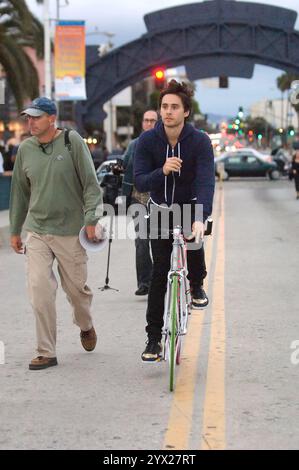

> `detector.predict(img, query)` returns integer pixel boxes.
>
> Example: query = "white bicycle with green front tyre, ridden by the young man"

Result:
[162,219,213,392]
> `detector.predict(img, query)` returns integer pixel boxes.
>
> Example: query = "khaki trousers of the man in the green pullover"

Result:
[26,232,92,357]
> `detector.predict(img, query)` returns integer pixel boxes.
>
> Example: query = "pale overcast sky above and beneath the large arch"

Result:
[26,0,299,115]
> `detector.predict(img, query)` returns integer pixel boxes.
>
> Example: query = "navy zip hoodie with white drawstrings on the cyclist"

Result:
[134,121,215,220]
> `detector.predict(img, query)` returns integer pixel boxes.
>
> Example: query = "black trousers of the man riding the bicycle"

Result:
[146,237,207,340]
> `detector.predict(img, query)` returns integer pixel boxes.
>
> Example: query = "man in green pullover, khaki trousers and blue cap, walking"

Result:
[10,97,102,370]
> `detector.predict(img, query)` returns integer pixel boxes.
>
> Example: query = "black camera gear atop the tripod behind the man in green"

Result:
[96,155,123,212]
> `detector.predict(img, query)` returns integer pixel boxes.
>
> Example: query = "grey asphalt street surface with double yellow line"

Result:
[0,178,299,450]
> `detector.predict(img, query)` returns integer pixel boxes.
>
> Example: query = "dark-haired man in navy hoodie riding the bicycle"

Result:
[134,80,215,362]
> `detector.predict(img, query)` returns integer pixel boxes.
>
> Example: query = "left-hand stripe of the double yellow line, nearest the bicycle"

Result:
[163,188,219,450]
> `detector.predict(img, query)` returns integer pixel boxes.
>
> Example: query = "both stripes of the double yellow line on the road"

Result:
[163,188,225,450]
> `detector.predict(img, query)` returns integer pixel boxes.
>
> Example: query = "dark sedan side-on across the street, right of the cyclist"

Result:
[215,148,280,180]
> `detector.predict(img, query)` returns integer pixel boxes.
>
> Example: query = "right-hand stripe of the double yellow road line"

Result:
[201,187,226,450]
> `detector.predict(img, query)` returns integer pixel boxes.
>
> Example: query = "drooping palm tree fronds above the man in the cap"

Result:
[0,0,43,110]
